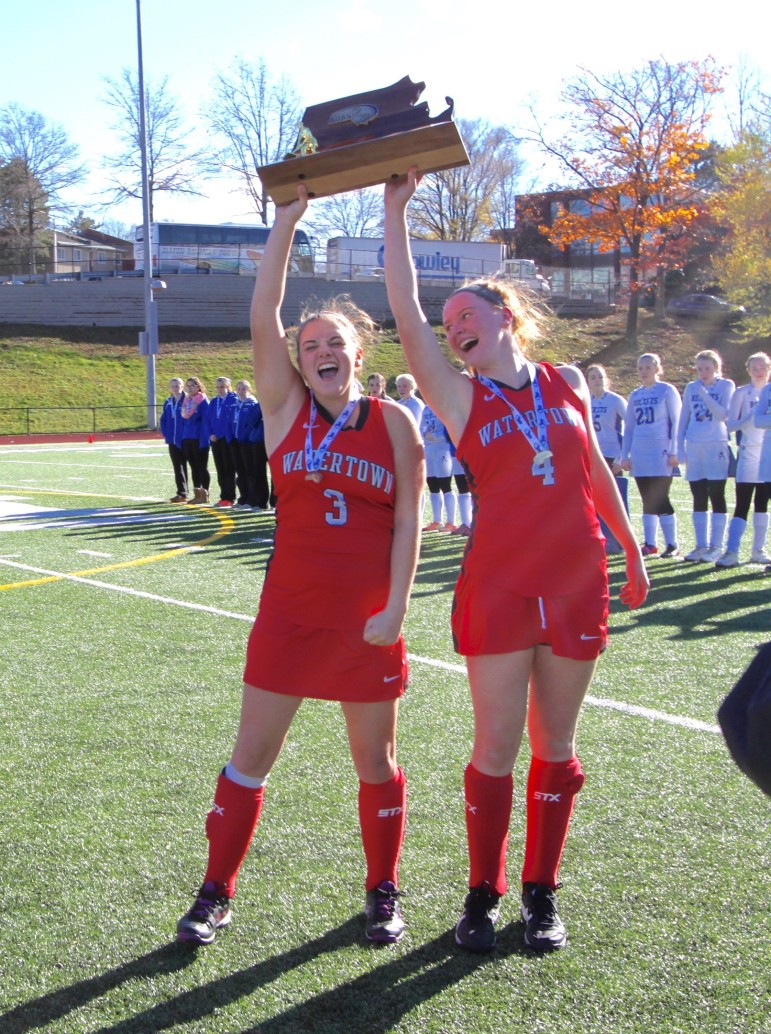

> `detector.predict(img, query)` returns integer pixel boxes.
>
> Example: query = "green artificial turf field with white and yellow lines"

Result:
[0,442,771,1034]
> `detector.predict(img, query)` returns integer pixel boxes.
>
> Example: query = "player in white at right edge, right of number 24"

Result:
[715,352,771,568]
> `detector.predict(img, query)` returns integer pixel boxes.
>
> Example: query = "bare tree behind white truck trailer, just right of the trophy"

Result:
[409,119,521,241]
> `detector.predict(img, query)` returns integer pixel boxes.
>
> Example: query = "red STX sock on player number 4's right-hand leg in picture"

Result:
[522,757,584,887]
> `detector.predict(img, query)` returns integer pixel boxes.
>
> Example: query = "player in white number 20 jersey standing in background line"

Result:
[619,352,681,557]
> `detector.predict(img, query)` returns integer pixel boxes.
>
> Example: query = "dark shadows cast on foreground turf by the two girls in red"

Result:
[0,915,533,1034]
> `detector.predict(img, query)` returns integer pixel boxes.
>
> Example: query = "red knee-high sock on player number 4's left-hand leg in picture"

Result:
[465,764,514,894]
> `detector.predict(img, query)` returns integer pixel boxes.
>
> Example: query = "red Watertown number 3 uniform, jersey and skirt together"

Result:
[244,394,407,701]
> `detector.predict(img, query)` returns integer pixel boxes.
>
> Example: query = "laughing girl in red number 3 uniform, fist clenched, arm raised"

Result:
[177,186,425,944]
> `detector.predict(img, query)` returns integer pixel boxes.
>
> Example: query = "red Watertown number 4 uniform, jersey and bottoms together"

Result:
[453,363,608,659]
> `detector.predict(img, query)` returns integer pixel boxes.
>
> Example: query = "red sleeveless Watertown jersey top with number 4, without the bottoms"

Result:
[457,363,607,597]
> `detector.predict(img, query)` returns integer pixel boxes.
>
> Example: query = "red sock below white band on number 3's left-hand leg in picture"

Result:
[206,772,265,898]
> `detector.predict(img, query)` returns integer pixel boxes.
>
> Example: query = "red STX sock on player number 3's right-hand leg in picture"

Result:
[359,768,407,890]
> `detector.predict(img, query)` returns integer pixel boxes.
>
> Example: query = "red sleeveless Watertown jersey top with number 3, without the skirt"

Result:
[260,394,396,629]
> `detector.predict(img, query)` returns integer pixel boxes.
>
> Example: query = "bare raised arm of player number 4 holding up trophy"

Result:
[384,169,472,442]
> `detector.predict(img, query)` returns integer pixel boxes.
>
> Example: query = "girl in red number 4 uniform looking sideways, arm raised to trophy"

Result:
[386,170,648,951]
